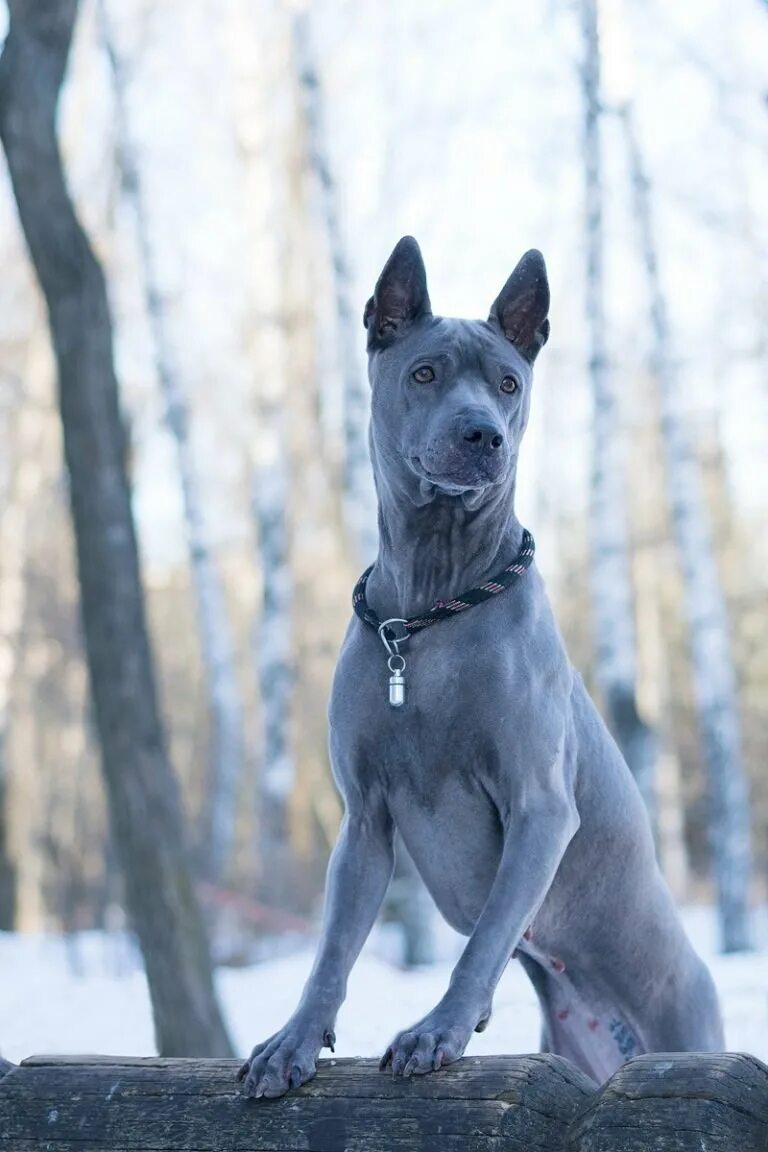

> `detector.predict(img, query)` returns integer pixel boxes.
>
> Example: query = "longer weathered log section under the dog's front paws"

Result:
[0,1055,595,1152]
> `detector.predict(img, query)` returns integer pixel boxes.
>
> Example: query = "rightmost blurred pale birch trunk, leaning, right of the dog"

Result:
[621,105,752,952]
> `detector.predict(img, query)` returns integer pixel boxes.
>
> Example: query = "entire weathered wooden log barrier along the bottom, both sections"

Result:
[0,1053,768,1152]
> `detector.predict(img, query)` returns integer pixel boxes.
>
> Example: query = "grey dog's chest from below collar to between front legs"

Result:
[332,604,571,932]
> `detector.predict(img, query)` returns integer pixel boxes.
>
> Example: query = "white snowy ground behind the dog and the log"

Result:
[0,909,768,1061]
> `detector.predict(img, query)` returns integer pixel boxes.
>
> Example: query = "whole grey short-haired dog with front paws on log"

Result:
[239,237,723,1097]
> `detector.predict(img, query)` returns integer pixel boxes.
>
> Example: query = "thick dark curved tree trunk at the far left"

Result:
[0,0,230,1056]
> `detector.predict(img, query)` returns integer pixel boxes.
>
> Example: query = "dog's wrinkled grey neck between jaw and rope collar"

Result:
[367,478,523,620]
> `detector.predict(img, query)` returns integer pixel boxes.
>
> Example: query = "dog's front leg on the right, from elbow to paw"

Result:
[381,764,579,1076]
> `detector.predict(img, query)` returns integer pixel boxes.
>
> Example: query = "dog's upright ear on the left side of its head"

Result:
[363,236,432,349]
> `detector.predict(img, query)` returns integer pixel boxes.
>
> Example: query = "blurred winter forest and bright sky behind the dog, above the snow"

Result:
[0,0,768,1054]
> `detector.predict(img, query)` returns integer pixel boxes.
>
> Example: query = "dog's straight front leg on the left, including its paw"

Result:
[238,801,394,1097]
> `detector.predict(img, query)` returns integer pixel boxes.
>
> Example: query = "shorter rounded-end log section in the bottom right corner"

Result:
[567,1052,768,1152]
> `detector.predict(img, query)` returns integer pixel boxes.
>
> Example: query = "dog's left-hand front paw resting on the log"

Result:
[237,1017,336,1097]
